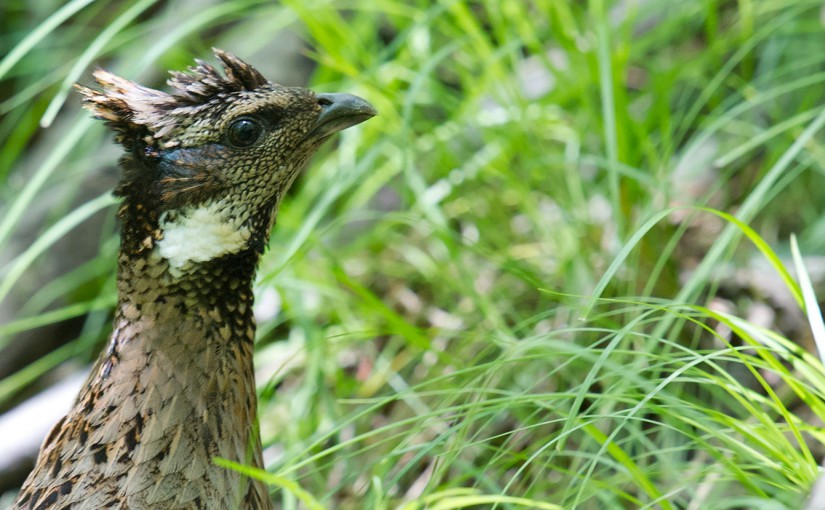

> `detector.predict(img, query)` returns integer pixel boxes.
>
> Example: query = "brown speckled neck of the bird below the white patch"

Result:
[20,237,272,510]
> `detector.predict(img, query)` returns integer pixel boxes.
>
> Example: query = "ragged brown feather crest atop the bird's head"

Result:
[75,48,269,146]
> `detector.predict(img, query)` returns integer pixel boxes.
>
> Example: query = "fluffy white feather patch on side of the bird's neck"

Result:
[155,201,251,277]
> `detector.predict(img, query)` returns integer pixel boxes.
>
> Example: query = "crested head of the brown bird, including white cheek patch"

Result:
[76,49,376,275]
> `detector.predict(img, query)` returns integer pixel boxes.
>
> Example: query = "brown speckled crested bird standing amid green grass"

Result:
[12,48,376,510]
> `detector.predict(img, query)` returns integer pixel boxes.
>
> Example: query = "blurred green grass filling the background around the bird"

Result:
[0,0,825,510]
